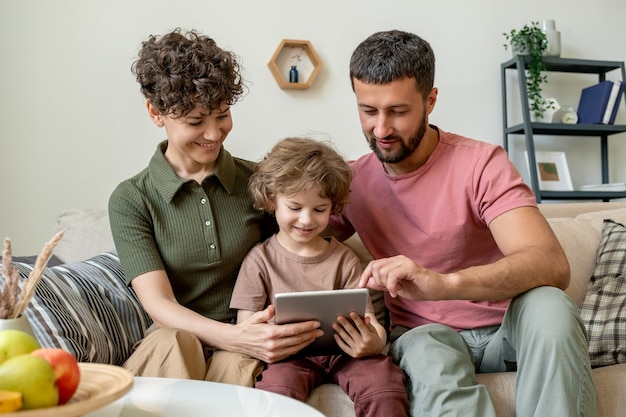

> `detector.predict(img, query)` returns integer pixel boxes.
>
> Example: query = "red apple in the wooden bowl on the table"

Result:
[30,348,80,404]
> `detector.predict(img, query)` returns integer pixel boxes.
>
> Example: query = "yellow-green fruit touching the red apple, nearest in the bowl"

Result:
[0,355,59,410]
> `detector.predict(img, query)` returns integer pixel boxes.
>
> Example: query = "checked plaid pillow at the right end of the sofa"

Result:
[581,219,626,367]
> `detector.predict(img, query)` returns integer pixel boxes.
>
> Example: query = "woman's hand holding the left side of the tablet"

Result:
[230,306,324,363]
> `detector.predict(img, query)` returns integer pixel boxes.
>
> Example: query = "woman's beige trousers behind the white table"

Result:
[123,328,263,387]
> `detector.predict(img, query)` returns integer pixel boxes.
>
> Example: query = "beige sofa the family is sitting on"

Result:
[33,202,626,417]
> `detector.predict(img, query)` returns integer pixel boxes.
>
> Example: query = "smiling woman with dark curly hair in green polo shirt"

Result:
[109,29,321,386]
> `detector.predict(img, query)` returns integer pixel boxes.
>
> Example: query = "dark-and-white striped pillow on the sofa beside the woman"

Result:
[6,252,151,365]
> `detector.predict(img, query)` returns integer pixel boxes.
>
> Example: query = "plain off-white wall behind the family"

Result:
[0,0,626,255]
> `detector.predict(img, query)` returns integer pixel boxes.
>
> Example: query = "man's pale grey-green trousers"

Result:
[390,287,596,417]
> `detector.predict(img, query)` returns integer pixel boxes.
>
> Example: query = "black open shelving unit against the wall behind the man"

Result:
[501,55,626,203]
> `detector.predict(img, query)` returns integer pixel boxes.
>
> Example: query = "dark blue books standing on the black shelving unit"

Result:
[577,80,624,125]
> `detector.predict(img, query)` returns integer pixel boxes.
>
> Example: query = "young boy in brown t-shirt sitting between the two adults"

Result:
[230,138,408,417]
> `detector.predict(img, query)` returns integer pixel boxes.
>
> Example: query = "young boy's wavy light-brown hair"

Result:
[249,137,352,214]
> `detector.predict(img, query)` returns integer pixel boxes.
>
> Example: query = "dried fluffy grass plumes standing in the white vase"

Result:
[0,230,65,319]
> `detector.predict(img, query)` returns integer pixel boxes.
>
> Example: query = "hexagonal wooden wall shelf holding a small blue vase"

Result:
[267,39,322,90]
